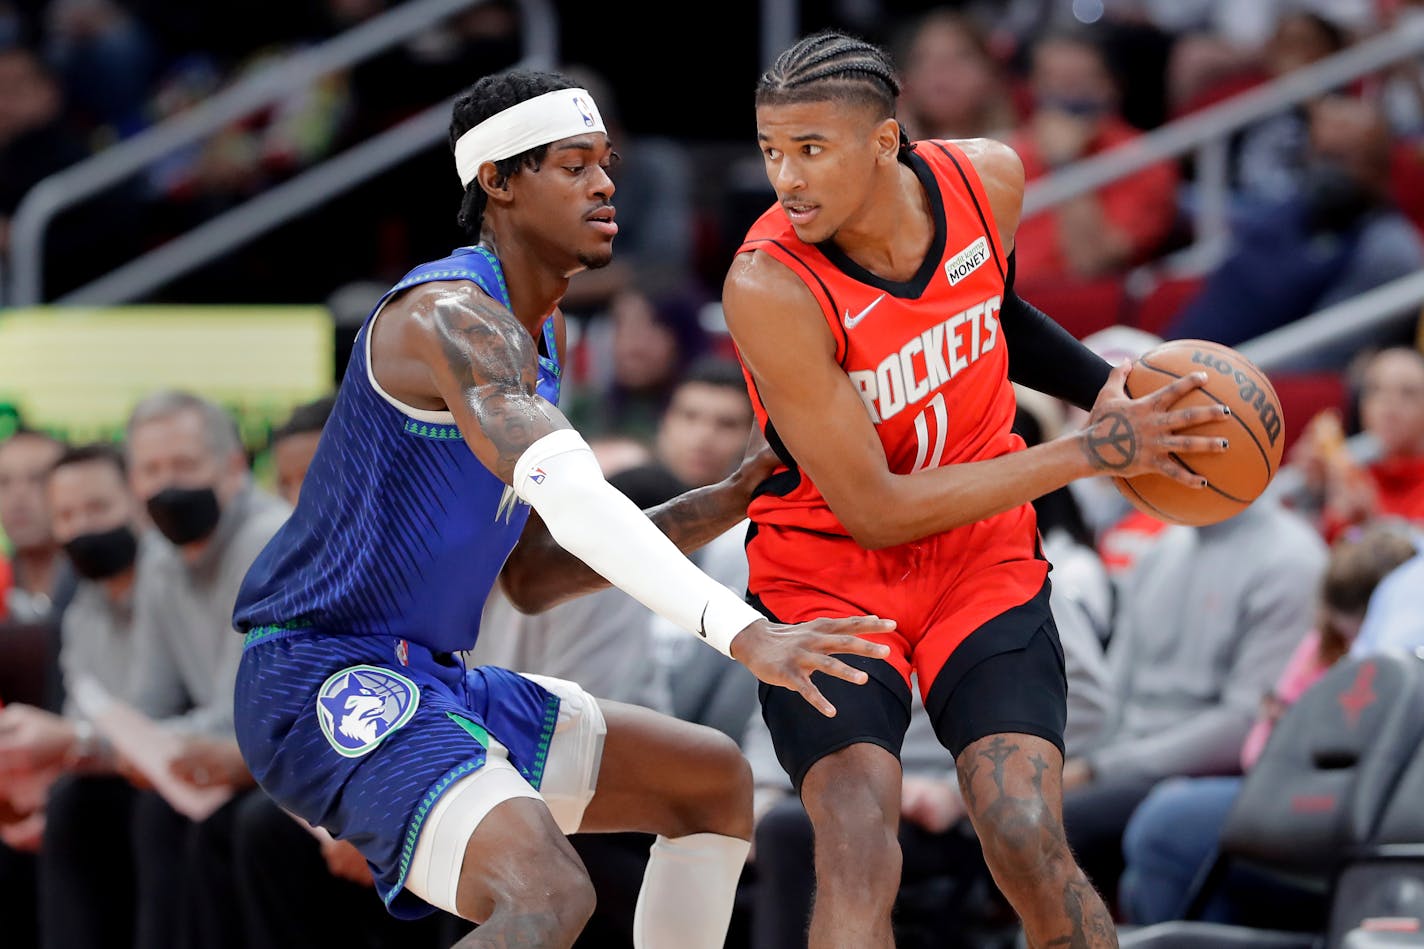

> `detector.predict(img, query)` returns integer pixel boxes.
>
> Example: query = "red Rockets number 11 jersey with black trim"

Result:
[738,140,1034,536]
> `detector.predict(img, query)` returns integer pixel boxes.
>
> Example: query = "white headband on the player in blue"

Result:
[454,88,607,187]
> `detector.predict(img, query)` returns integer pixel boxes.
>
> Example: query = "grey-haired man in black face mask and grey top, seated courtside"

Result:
[127,390,290,949]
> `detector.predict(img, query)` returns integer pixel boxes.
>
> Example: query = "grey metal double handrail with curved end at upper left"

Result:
[9,0,558,306]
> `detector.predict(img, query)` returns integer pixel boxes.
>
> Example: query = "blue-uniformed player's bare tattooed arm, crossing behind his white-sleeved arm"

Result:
[500,449,778,613]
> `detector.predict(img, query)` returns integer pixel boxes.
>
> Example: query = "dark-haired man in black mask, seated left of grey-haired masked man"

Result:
[0,445,153,949]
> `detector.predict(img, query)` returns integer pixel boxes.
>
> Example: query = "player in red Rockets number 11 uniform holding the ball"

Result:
[722,33,1225,949]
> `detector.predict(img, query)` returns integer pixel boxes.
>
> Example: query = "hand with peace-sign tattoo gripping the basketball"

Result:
[1078,362,1230,487]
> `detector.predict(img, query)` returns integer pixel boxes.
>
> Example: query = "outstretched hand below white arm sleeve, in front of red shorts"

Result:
[732,616,894,718]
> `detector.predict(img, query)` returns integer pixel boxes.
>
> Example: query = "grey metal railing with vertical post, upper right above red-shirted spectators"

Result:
[1024,20,1424,262]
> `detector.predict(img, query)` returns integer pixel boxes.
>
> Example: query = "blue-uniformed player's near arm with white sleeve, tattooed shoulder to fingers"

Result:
[395,285,894,715]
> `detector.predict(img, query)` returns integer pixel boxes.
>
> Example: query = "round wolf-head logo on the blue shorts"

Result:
[316,665,420,758]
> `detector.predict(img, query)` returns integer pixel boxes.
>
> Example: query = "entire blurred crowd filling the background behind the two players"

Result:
[0,0,1424,949]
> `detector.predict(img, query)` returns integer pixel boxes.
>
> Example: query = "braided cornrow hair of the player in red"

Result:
[756,30,914,151]
